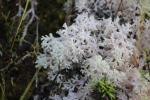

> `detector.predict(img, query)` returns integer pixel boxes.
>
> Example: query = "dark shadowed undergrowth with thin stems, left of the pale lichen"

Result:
[0,0,65,100]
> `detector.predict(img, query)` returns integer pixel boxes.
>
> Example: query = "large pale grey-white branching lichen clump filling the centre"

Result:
[36,0,150,100]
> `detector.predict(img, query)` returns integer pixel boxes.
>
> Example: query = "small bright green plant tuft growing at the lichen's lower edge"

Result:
[96,78,116,100]
